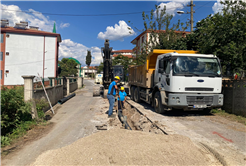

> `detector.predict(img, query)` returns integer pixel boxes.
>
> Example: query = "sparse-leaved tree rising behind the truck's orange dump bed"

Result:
[129,5,189,65]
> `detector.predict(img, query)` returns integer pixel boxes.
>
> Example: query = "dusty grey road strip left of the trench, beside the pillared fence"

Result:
[2,80,106,165]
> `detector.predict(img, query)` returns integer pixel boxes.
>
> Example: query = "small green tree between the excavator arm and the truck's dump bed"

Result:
[112,54,134,81]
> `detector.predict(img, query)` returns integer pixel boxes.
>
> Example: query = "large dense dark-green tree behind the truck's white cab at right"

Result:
[194,0,246,72]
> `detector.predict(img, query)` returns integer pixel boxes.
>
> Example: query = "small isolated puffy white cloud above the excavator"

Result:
[97,20,135,41]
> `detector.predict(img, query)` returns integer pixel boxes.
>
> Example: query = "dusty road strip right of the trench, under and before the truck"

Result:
[128,100,246,165]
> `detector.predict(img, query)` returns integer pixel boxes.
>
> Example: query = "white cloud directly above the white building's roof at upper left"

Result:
[0,4,66,32]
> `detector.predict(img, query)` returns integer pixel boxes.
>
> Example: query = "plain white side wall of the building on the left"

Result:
[4,33,56,85]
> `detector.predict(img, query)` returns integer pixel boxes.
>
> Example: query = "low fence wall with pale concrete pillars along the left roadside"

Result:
[22,76,83,117]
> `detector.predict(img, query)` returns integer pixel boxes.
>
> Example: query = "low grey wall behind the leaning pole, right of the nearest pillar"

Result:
[33,85,64,105]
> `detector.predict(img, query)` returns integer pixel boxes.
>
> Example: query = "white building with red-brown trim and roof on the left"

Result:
[0,20,61,85]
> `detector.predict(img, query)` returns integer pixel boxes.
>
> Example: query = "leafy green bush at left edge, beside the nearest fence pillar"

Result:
[0,87,32,135]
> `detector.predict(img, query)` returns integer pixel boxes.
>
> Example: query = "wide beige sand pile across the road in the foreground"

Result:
[33,129,209,165]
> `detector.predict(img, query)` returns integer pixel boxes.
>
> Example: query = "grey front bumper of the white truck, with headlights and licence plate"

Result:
[168,93,223,109]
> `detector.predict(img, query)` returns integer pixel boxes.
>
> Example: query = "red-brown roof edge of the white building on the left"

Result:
[0,27,62,42]
